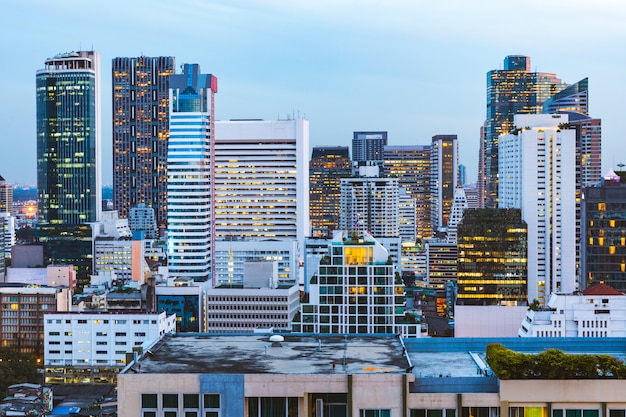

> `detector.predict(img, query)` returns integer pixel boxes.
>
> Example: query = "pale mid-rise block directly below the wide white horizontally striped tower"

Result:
[214,239,299,285]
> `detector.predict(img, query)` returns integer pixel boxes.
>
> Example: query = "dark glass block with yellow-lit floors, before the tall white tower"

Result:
[457,209,528,305]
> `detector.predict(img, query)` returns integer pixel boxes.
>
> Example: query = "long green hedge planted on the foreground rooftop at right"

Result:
[486,343,626,380]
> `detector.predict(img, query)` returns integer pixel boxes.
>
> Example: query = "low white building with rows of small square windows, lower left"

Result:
[43,312,176,383]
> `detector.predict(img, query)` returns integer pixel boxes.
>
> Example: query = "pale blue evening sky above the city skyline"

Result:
[0,0,626,185]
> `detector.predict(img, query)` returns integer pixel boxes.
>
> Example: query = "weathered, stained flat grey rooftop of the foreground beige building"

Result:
[129,334,409,374]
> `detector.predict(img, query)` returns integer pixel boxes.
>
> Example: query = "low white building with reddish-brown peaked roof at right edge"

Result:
[518,283,626,337]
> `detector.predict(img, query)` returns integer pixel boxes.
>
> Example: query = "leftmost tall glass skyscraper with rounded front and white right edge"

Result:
[36,51,102,225]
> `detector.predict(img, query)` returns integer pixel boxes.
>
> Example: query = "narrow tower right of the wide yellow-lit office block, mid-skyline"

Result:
[430,135,459,233]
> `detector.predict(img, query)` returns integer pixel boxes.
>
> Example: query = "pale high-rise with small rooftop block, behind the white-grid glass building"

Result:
[339,166,400,238]
